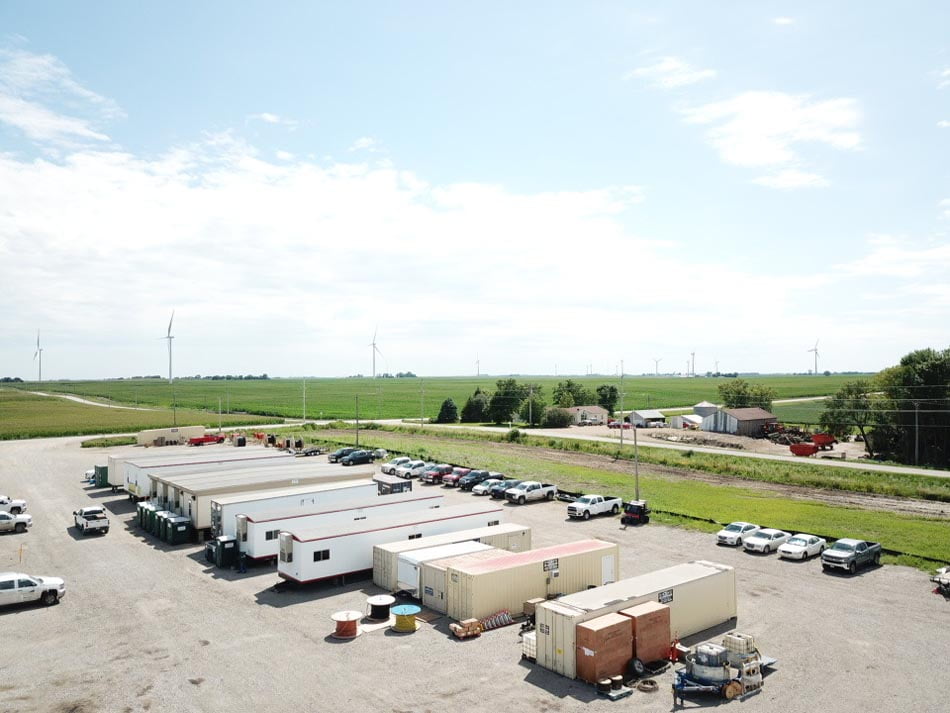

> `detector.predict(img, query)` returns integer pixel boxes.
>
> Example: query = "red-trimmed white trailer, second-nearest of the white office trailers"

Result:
[235,490,442,560]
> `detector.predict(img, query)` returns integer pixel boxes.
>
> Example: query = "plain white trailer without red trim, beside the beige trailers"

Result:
[211,480,379,537]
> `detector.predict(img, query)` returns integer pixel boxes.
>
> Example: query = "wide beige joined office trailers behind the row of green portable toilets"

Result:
[149,459,373,530]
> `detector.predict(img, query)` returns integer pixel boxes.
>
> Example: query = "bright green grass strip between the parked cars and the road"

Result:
[296,422,950,569]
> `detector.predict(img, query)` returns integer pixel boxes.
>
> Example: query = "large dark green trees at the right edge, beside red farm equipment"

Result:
[819,349,950,468]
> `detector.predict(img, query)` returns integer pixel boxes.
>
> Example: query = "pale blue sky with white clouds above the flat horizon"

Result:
[0,0,950,380]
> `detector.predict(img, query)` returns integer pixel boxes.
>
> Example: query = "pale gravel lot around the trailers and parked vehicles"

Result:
[0,438,950,713]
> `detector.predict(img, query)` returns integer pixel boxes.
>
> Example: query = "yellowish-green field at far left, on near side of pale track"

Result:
[0,388,276,440]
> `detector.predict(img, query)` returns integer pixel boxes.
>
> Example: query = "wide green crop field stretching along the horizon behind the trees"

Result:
[23,376,872,418]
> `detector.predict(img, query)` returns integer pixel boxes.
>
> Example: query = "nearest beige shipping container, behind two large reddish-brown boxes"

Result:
[535,560,737,678]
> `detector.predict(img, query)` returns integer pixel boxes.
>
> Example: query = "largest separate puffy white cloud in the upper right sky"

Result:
[682,92,861,188]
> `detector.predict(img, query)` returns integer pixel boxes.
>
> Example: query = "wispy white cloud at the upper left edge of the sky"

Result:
[0,49,124,147]
